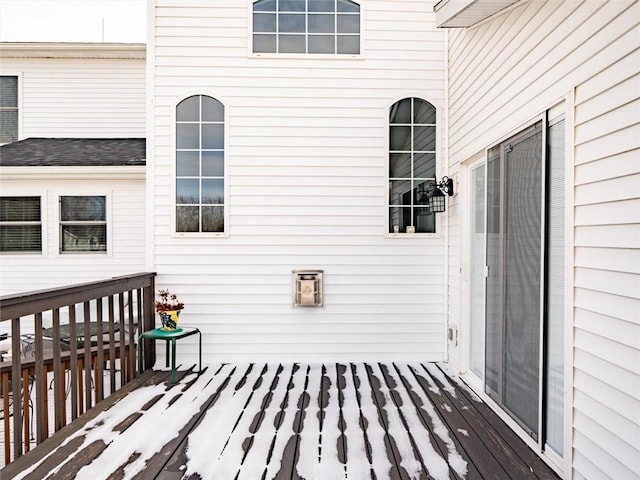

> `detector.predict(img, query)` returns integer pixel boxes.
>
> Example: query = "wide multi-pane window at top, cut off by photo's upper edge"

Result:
[253,0,360,55]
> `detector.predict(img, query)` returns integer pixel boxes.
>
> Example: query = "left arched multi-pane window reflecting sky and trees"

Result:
[176,95,225,232]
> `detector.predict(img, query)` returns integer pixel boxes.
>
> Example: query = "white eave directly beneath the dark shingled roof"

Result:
[0,165,146,182]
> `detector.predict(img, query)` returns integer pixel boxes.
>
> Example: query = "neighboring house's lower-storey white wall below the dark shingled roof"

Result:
[0,167,145,295]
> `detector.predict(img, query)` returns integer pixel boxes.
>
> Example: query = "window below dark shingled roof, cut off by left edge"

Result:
[0,197,42,253]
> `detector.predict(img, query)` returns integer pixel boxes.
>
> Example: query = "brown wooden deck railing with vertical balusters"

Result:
[0,273,155,464]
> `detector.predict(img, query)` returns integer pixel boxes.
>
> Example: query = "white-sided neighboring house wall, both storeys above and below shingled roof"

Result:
[0,43,146,294]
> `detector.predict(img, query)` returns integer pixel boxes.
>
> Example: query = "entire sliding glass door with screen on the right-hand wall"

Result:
[468,113,565,455]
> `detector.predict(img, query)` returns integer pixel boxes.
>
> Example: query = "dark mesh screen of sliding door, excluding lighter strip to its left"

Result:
[503,124,542,438]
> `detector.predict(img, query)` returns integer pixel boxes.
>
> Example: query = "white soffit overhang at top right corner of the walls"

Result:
[434,0,521,28]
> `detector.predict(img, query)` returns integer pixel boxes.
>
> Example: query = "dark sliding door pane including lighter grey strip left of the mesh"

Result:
[485,122,543,438]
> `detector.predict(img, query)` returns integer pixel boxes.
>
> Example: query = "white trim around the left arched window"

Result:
[168,90,229,238]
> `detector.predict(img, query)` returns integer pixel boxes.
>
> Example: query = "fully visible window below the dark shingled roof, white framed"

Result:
[60,196,107,253]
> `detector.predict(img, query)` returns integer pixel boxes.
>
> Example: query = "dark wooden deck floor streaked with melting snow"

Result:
[0,363,558,480]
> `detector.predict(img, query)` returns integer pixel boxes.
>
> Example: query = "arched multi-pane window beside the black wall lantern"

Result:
[389,97,436,233]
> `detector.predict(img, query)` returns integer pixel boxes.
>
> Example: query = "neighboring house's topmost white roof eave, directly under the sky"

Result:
[0,42,147,60]
